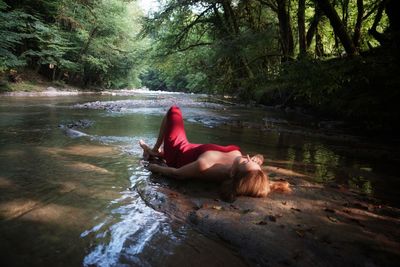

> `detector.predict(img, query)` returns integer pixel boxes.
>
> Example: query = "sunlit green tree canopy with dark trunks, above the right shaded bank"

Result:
[144,0,398,97]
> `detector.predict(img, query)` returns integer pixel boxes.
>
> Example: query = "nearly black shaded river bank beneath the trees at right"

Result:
[256,47,400,136]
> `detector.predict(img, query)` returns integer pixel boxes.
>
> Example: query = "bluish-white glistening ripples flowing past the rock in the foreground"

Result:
[81,171,173,266]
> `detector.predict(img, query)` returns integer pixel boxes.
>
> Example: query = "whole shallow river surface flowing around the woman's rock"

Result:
[0,93,399,266]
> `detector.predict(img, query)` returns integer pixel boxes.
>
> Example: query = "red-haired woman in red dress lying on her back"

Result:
[139,106,290,200]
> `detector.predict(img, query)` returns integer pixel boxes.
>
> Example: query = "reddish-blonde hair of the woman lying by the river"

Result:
[221,170,291,201]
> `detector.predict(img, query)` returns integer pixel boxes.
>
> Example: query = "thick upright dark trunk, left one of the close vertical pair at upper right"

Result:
[277,0,294,61]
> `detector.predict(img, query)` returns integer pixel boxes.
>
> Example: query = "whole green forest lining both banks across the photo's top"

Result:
[0,0,400,133]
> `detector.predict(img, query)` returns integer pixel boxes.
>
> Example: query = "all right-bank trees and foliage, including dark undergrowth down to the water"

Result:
[142,0,400,131]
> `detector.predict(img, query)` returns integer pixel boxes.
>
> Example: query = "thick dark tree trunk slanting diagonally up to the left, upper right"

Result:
[316,0,357,56]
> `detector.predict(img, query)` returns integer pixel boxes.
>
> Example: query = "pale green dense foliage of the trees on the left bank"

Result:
[0,0,144,88]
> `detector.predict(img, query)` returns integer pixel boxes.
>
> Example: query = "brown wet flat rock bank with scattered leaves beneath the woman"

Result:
[135,167,400,266]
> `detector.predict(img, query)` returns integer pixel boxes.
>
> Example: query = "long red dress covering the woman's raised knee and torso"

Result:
[164,106,240,168]
